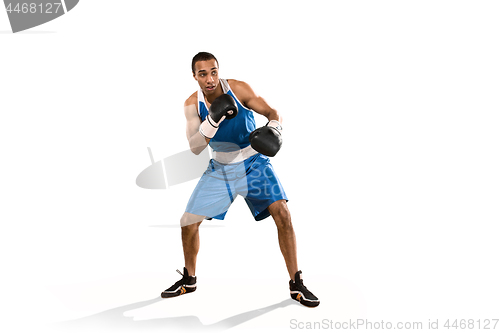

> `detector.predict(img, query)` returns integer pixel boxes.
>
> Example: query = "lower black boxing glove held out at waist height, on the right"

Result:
[249,120,282,157]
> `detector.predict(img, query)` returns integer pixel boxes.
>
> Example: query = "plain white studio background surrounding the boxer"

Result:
[0,0,500,332]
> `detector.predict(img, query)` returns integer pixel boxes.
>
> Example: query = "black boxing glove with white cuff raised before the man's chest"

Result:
[200,94,238,139]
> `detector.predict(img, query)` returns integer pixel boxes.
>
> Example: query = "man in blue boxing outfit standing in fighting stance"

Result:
[161,52,319,307]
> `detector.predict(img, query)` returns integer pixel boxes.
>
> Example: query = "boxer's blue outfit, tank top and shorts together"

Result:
[186,79,288,221]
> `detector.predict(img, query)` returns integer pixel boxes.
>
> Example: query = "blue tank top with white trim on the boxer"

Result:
[198,79,255,152]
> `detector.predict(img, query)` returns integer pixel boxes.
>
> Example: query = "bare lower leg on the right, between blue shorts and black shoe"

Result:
[268,200,299,280]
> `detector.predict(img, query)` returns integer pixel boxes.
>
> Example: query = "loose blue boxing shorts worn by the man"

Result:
[186,154,288,221]
